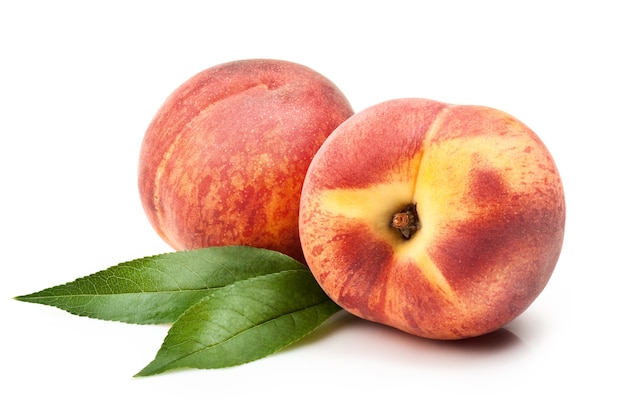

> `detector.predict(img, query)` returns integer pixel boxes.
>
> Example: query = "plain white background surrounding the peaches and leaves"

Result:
[0,0,626,417]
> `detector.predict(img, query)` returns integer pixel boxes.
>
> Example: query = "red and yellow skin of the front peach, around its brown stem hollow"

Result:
[300,99,565,339]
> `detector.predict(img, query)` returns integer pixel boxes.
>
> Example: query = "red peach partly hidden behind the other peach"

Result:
[139,59,354,261]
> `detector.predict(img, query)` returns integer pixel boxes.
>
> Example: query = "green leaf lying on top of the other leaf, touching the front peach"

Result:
[137,271,341,376]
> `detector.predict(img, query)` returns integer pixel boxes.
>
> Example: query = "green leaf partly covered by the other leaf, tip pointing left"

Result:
[16,246,308,324]
